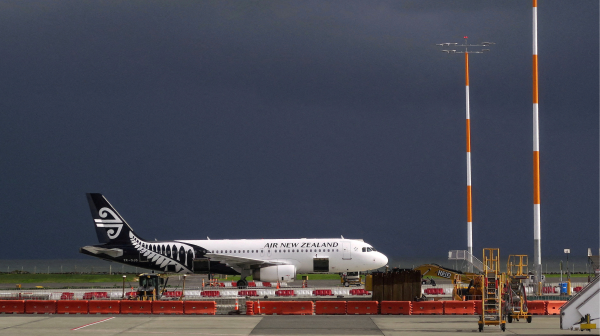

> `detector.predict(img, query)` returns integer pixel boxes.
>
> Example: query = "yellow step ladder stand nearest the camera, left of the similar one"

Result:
[478,248,506,332]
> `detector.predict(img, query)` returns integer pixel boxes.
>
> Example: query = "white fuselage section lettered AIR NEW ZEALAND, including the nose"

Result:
[178,238,388,273]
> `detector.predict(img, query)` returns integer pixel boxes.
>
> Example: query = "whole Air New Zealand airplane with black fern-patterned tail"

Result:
[79,193,388,288]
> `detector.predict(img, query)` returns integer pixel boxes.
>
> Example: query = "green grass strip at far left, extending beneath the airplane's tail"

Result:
[0,274,136,284]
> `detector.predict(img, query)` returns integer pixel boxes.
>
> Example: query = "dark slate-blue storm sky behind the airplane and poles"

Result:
[0,0,600,259]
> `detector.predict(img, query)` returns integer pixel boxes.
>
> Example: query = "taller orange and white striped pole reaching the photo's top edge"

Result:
[533,0,542,282]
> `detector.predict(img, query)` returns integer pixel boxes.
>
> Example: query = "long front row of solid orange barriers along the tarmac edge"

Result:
[0,300,566,315]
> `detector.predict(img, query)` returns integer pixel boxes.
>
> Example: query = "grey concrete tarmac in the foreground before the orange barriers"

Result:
[0,315,588,336]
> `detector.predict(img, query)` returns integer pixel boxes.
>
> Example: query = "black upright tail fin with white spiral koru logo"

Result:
[86,194,141,245]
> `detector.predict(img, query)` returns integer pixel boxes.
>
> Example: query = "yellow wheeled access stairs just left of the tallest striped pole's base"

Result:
[504,255,532,323]
